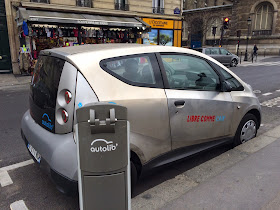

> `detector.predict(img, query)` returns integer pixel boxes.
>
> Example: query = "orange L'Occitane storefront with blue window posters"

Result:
[142,18,182,47]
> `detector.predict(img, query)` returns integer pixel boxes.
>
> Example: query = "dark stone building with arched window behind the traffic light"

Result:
[182,0,280,55]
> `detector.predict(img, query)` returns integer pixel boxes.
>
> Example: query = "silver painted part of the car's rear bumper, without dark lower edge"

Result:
[21,111,78,180]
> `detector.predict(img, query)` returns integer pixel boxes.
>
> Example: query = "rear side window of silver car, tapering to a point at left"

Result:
[100,54,163,87]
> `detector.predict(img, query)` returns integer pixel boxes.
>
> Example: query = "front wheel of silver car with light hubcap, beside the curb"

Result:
[233,113,258,146]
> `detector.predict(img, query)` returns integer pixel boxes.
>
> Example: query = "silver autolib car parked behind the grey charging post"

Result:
[21,44,261,192]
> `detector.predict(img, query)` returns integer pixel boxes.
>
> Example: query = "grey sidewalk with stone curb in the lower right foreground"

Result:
[132,126,280,209]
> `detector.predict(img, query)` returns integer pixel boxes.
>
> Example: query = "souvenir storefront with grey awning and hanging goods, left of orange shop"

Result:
[17,8,150,73]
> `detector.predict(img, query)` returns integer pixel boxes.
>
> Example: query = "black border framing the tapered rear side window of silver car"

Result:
[99,53,164,89]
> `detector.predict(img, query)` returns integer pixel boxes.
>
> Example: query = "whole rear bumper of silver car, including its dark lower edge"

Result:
[21,111,78,193]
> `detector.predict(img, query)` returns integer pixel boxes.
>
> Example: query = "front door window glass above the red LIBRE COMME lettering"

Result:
[161,54,220,91]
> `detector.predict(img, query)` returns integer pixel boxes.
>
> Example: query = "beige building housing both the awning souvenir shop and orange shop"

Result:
[4,0,182,74]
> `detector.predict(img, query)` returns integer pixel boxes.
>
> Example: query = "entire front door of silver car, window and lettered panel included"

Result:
[158,53,233,150]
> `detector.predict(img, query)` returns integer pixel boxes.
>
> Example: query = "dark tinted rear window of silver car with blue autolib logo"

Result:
[29,56,65,132]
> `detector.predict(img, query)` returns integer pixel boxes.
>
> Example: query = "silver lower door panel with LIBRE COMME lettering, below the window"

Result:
[166,90,233,149]
